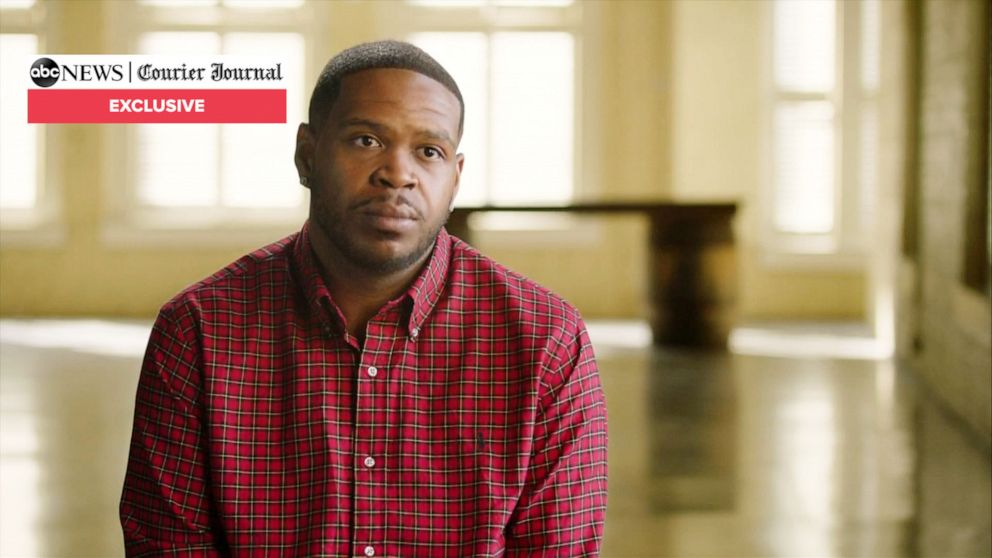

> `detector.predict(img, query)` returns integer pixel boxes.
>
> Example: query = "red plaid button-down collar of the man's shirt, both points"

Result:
[293,221,451,337]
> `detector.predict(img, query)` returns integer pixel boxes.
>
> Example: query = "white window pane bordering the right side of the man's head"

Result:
[410,33,489,206]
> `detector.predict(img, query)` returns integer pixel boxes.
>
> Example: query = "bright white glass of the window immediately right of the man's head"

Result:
[410,32,575,205]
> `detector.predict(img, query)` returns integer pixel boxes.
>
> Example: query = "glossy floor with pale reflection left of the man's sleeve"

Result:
[0,340,139,557]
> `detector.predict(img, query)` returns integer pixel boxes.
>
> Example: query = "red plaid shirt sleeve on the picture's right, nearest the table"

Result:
[506,322,607,557]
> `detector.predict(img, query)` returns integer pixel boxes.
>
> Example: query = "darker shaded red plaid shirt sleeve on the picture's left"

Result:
[120,307,222,556]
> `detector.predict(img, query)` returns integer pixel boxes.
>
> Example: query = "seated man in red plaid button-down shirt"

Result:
[121,41,606,557]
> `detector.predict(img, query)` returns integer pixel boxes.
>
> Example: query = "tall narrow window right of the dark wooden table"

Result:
[765,0,879,254]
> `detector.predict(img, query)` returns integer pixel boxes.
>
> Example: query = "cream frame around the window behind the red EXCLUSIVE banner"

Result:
[101,2,323,247]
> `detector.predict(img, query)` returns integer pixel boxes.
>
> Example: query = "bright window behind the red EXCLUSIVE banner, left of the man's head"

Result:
[115,0,306,231]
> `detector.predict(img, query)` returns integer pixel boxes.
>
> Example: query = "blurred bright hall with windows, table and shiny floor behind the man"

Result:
[0,0,992,558]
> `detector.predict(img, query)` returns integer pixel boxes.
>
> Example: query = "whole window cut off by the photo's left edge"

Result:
[0,0,45,229]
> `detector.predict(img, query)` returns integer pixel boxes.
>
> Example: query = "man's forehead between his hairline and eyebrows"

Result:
[329,68,461,137]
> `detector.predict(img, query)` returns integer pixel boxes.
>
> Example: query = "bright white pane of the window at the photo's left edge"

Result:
[0,33,38,208]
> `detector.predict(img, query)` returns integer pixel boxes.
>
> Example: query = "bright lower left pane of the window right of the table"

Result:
[774,101,834,233]
